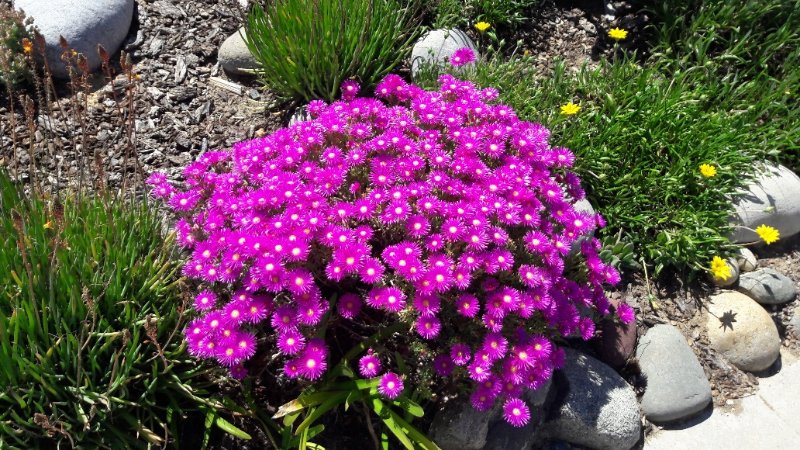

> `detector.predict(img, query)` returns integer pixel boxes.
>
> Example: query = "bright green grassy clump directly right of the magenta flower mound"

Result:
[416,58,765,274]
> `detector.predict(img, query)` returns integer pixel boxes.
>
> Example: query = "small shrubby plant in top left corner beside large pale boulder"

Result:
[0,3,33,87]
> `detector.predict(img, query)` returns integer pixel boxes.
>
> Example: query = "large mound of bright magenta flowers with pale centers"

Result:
[150,75,630,426]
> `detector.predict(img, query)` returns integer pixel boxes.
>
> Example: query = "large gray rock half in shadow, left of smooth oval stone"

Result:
[544,349,641,450]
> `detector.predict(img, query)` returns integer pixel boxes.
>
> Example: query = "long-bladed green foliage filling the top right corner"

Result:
[650,0,800,170]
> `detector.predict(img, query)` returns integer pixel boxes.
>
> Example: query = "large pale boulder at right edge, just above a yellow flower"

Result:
[732,165,800,242]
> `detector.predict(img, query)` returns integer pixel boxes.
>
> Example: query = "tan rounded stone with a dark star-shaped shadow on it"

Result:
[706,291,781,372]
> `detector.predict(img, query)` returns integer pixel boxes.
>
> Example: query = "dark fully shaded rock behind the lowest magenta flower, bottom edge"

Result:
[483,379,554,450]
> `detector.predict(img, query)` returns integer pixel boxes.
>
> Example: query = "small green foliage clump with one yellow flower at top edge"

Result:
[436,0,541,30]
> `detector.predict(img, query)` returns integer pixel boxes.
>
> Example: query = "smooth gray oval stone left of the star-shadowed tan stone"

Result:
[636,324,711,423]
